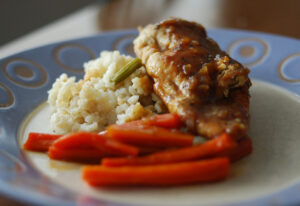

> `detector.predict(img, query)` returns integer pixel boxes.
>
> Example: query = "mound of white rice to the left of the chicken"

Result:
[48,51,166,133]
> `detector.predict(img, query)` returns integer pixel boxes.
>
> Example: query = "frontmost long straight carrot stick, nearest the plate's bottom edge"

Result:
[82,158,229,186]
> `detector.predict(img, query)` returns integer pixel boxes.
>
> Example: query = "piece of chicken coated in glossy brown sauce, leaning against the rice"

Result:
[134,19,251,139]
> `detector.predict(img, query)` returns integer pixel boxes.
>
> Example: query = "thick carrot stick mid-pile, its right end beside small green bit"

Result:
[107,124,194,148]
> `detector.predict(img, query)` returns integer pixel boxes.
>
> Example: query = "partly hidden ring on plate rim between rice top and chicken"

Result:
[113,34,137,56]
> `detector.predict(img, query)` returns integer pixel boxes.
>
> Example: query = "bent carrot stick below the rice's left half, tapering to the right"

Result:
[52,132,139,156]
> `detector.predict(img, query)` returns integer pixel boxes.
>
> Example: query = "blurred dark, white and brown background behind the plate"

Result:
[0,0,300,206]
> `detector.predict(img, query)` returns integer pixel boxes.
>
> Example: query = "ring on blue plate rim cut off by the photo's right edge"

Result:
[278,52,300,83]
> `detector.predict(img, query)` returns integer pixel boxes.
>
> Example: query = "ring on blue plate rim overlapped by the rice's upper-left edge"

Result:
[53,43,95,73]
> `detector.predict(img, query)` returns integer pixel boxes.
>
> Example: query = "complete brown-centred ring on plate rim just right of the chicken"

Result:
[227,37,269,66]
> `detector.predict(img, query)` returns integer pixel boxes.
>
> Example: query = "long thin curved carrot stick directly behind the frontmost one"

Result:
[102,133,237,167]
